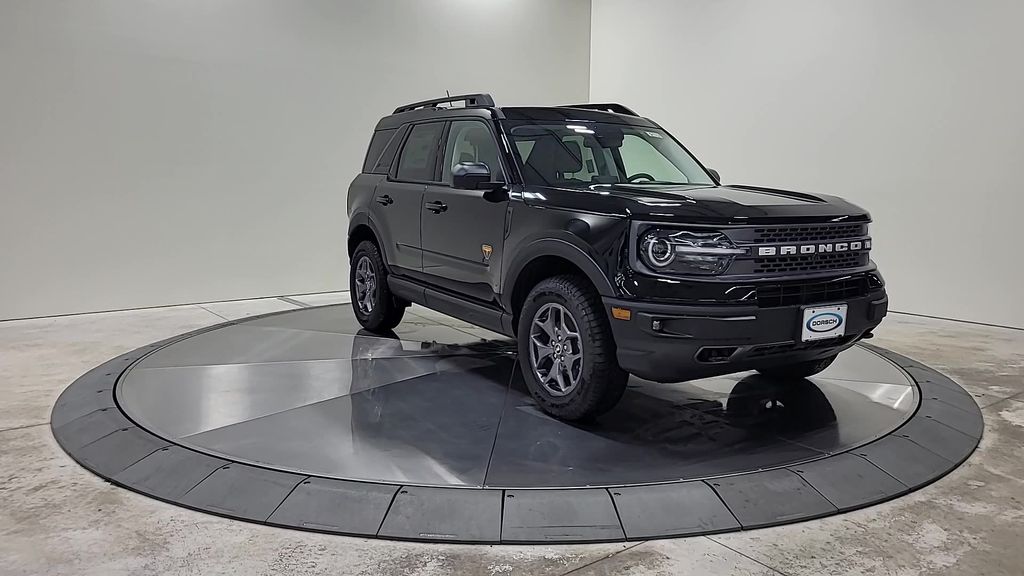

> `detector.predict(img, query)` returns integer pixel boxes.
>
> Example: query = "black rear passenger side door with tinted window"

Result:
[370,122,444,275]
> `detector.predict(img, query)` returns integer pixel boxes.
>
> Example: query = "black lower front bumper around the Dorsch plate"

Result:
[604,290,889,382]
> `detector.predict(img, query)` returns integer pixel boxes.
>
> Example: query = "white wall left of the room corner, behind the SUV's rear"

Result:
[0,0,590,319]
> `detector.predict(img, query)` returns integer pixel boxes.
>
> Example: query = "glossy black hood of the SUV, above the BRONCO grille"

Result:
[522,184,869,223]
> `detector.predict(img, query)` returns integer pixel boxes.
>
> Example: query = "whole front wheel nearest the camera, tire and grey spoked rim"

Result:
[517,276,629,420]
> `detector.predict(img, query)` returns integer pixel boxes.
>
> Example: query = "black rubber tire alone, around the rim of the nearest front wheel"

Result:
[516,275,629,420]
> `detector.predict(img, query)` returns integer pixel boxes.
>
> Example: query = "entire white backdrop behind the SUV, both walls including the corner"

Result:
[6,0,1024,326]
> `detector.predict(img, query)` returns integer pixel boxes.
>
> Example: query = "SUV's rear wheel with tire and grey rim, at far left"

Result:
[348,240,409,332]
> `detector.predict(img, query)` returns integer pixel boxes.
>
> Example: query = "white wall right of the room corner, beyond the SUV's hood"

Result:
[591,0,1024,327]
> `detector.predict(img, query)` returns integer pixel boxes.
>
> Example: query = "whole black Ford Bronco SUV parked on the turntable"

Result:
[348,94,888,419]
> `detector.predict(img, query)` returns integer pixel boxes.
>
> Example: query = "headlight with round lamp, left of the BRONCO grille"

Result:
[638,230,746,276]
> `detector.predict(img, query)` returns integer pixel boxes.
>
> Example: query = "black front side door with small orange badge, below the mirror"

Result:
[421,120,508,302]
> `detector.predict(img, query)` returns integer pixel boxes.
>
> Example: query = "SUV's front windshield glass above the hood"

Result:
[509,121,714,188]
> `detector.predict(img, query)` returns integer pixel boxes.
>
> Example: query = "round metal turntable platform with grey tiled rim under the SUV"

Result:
[51,305,982,542]
